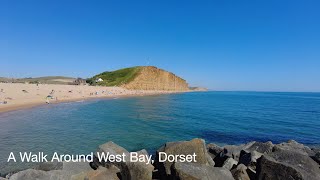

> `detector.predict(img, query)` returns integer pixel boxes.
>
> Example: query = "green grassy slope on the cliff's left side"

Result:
[87,66,141,86]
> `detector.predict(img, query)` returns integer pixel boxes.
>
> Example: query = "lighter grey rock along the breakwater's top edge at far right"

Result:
[275,140,315,156]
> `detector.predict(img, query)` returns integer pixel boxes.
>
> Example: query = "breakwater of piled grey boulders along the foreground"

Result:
[0,139,320,180]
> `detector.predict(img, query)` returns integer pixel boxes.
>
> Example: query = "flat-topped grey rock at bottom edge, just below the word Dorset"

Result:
[172,162,234,180]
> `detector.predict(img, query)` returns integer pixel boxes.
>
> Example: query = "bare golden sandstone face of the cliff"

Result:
[122,66,189,91]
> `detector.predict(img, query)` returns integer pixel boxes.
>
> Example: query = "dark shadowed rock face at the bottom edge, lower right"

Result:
[256,156,303,180]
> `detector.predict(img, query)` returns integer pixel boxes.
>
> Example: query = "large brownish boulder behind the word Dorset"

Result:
[155,139,214,178]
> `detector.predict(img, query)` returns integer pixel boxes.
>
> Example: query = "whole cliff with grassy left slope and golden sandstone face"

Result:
[89,66,189,91]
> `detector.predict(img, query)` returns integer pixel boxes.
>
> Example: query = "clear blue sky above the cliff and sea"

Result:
[0,0,320,91]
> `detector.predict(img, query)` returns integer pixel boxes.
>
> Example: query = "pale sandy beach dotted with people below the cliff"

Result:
[0,83,180,112]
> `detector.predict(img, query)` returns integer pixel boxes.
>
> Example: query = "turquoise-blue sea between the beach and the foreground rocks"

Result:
[0,92,320,173]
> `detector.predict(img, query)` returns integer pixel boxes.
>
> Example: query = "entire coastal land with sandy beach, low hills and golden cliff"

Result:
[0,66,205,112]
